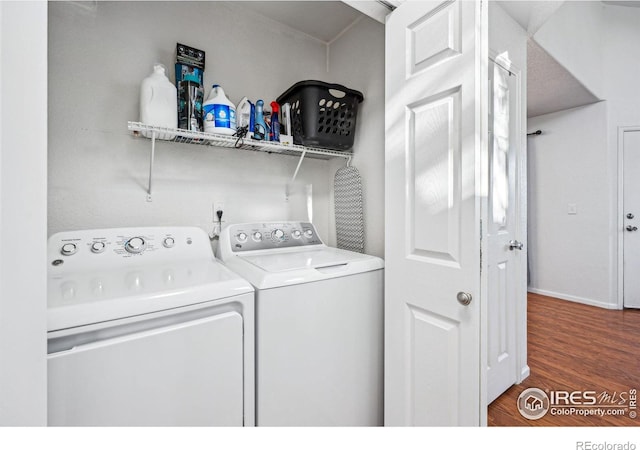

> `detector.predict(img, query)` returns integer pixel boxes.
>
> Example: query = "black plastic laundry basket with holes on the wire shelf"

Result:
[277,80,364,150]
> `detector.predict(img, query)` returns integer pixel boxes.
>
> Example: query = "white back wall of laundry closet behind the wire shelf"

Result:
[49,2,330,243]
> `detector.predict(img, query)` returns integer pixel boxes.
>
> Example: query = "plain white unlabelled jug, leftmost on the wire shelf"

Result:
[140,64,178,140]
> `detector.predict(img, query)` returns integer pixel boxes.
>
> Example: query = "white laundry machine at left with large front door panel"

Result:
[47,227,255,426]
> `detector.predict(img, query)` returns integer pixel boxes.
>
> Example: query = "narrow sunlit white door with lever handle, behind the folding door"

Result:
[486,57,523,403]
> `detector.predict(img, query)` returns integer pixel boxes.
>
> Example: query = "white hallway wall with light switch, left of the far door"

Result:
[528,102,617,308]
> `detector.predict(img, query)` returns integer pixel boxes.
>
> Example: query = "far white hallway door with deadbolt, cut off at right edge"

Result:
[622,131,640,308]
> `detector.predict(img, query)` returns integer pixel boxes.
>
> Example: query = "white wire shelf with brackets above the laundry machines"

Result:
[128,122,353,202]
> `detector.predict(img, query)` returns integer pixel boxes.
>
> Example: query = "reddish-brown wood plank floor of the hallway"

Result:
[488,294,640,426]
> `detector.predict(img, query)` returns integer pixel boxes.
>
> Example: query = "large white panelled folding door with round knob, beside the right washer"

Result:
[385,1,488,426]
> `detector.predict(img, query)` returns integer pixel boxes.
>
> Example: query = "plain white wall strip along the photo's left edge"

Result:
[0,1,47,426]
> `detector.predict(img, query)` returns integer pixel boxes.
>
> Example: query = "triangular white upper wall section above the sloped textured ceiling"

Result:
[533,1,604,99]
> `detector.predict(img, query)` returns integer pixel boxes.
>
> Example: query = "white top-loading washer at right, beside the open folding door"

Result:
[217,222,384,426]
